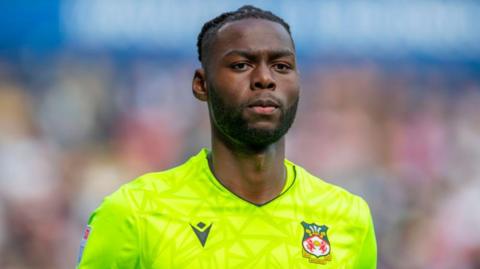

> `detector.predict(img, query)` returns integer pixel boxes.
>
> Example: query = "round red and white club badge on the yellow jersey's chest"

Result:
[302,221,332,264]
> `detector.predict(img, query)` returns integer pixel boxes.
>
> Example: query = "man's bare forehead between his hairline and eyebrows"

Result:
[211,18,294,58]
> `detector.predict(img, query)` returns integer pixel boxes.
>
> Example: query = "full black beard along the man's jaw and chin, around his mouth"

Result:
[208,87,299,150]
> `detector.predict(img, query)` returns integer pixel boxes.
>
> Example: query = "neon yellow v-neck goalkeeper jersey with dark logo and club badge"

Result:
[77,149,377,269]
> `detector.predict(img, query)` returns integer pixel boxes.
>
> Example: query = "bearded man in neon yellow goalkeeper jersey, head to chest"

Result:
[78,6,376,269]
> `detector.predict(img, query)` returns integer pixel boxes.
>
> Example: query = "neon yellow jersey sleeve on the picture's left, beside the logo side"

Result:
[77,189,140,269]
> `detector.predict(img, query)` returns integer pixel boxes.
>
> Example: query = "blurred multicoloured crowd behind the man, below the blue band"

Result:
[0,53,480,269]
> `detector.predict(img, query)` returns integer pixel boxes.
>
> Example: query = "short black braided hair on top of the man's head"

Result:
[197,5,293,64]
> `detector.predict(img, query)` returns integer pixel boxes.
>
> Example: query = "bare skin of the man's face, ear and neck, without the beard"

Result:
[192,19,300,205]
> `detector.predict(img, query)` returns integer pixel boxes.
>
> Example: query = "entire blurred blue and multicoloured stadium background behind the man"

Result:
[0,0,480,269]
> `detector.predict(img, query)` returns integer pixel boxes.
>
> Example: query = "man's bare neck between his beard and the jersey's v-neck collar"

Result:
[209,129,286,205]
